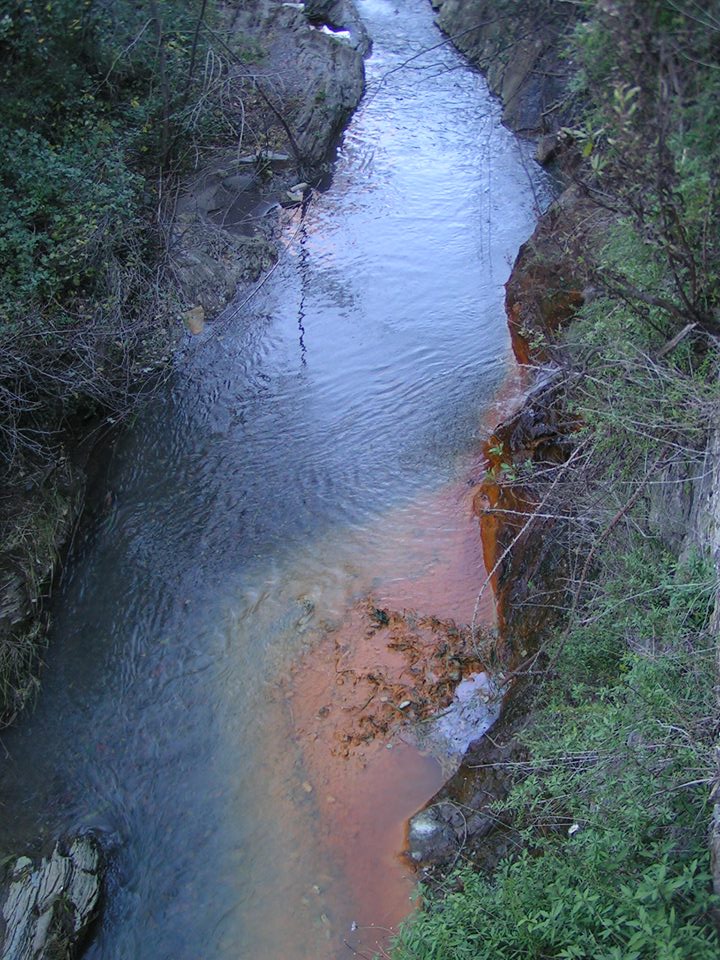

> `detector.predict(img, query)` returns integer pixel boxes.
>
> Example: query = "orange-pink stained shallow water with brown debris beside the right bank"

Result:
[262,354,540,960]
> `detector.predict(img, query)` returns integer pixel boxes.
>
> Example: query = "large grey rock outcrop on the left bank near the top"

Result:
[171,0,370,320]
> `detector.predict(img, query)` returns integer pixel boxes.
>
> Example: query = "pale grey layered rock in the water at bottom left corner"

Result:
[0,835,104,960]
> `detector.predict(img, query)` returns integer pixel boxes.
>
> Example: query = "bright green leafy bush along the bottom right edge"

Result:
[394,852,718,960]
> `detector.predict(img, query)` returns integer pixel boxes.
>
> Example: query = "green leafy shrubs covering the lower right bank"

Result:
[394,548,720,960]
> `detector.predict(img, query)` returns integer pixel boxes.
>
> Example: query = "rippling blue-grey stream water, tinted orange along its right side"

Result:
[0,0,537,960]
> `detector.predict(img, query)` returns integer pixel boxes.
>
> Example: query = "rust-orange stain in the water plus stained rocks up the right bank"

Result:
[272,178,596,958]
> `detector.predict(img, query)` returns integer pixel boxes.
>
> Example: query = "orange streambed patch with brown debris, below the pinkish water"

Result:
[289,599,490,952]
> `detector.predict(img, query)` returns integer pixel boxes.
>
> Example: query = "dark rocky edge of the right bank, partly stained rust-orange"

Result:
[410,0,592,881]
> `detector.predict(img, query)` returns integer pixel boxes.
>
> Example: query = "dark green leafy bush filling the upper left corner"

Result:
[0,0,228,471]
